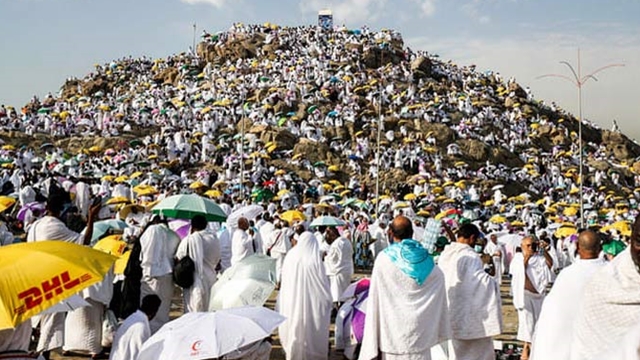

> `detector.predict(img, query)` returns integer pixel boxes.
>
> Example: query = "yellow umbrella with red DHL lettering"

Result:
[0,241,116,330]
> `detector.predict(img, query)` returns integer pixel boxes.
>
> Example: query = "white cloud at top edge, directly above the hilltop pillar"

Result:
[300,0,387,26]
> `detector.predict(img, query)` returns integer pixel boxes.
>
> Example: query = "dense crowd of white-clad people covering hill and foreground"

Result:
[0,24,640,360]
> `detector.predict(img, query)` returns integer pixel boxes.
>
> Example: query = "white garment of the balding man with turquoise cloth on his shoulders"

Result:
[359,252,451,360]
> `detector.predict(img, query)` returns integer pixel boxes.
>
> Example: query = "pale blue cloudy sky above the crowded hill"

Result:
[0,0,640,139]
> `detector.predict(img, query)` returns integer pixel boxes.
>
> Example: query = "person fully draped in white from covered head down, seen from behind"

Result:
[276,232,332,360]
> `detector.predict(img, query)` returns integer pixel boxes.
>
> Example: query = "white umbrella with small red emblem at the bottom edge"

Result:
[137,307,285,360]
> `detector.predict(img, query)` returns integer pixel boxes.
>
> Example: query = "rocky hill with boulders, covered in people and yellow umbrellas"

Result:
[0,24,640,200]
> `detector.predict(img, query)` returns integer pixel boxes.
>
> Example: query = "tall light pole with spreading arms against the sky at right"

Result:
[537,49,624,229]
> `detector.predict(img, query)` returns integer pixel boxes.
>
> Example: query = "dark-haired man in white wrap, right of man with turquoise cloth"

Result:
[438,224,502,360]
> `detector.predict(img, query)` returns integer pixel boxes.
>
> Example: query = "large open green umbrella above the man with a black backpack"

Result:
[151,194,227,222]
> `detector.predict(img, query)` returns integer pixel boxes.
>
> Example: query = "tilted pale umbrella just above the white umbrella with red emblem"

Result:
[209,255,276,311]
